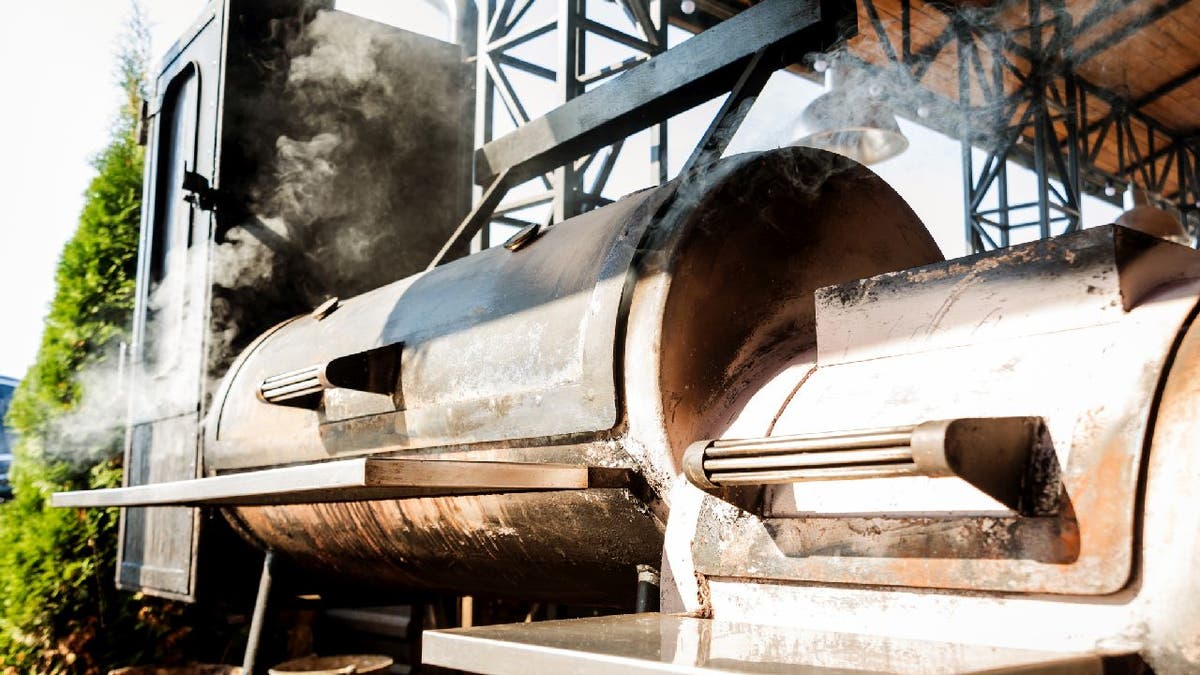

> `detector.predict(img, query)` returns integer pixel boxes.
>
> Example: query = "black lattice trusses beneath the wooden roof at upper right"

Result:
[856,0,1200,252]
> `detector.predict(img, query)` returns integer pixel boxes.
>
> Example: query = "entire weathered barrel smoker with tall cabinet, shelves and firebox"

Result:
[55,1,1200,673]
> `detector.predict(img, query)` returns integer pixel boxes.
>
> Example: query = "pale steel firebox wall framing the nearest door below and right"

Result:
[704,306,1200,675]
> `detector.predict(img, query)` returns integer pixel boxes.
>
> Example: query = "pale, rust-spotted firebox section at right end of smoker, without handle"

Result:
[628,226,1200,673]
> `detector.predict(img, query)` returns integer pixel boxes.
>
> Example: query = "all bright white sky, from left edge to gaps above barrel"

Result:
[0,0,1116,377]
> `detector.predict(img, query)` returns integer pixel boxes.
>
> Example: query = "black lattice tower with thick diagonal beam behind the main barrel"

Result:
[430,0,857,268]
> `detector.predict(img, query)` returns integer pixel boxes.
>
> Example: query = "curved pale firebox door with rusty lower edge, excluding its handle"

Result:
[695,229,1200,595]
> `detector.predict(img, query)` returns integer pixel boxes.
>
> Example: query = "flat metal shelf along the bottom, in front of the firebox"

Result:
[421,614,1104,675]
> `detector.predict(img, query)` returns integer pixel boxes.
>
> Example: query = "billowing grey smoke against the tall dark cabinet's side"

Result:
[209,11,466,377]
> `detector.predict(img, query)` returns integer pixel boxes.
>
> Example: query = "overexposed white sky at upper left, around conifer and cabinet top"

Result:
[0,0,440,378]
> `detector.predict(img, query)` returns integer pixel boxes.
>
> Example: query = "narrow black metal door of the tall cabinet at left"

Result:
[118,6,224,599]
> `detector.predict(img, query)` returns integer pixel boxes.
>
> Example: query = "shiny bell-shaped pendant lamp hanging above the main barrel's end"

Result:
[792,59,908,165]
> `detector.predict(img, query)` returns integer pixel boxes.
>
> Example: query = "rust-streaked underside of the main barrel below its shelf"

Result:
[233,489,661,607]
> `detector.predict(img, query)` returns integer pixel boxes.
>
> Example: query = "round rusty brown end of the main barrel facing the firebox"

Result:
[624,148,942,504]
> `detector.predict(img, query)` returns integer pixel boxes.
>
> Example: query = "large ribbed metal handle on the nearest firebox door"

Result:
[683,417,1052,510]
